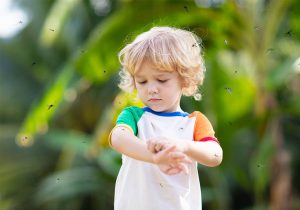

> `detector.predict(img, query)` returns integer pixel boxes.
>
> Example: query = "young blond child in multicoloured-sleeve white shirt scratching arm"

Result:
[110,27,223,210]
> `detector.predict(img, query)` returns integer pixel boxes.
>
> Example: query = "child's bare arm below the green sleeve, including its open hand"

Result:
[110,126,191,175]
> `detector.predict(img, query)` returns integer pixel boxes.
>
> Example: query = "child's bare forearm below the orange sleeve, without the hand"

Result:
[185,141,223,167]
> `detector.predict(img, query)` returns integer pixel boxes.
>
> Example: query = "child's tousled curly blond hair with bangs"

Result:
[118,27,205,96]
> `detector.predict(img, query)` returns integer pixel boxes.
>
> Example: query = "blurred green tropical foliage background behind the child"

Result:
[0,0,300,210]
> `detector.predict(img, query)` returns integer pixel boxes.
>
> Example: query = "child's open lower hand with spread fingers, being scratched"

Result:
[153,146,192,175]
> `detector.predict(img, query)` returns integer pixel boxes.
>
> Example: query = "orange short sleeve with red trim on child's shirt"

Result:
[189,111,219,143]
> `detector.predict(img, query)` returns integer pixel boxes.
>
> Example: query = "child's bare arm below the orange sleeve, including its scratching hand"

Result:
[148,138,223,167]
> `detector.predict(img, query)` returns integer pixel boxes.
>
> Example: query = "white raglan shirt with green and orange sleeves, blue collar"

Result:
[114,106,218,210]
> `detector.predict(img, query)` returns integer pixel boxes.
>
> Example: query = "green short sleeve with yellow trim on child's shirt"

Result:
[116,106,144,135]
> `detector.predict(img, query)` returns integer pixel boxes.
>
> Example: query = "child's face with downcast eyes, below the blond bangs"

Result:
[134,60,182,112]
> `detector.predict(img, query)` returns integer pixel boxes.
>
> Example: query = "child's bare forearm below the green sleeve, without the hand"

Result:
[111,128,154,163]
